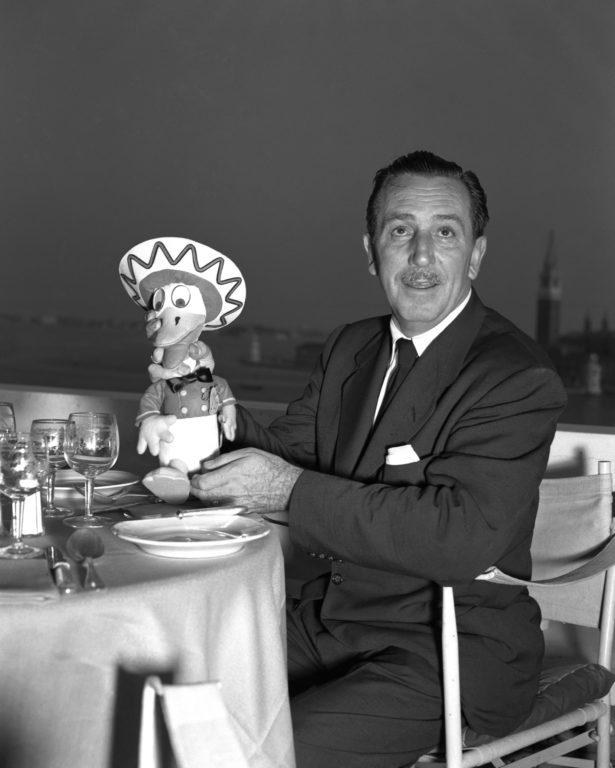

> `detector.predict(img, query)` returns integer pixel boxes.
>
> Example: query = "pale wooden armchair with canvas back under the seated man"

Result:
[428,461,615,768]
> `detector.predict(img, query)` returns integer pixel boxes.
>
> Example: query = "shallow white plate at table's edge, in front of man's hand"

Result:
[111,515,270,558]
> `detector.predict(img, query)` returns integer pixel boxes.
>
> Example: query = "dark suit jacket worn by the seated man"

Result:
[238,295,566,734]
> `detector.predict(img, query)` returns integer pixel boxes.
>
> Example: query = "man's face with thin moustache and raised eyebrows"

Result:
[364,174,487,336]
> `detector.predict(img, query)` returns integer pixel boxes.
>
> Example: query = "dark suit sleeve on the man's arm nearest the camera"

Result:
[289,365,565,584]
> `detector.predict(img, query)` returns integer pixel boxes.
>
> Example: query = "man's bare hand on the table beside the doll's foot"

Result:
[192,448,303,512]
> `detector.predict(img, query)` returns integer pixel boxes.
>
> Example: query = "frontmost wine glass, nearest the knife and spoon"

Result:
[0,432,46,560]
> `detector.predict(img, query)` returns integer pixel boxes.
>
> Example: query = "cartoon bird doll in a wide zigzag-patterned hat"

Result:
[120,237,246,504]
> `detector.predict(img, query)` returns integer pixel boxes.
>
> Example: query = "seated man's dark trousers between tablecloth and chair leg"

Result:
[287,600,443,768]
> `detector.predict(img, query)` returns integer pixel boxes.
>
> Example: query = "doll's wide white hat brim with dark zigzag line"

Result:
[120,237,246,330]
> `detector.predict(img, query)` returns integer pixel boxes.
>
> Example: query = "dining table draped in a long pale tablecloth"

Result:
[0,488,295,768]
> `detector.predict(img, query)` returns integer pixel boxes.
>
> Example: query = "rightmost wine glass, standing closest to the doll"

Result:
[63,412,120,528]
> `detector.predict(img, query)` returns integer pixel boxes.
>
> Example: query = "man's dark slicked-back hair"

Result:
[366,150,489,244]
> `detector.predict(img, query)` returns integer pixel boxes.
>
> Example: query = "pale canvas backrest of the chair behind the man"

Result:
[530,462,615,627]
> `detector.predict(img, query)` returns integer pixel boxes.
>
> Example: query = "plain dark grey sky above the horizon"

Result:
[0,0,615,333]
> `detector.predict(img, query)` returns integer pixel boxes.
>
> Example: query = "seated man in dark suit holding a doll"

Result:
[192,152,565,768]
